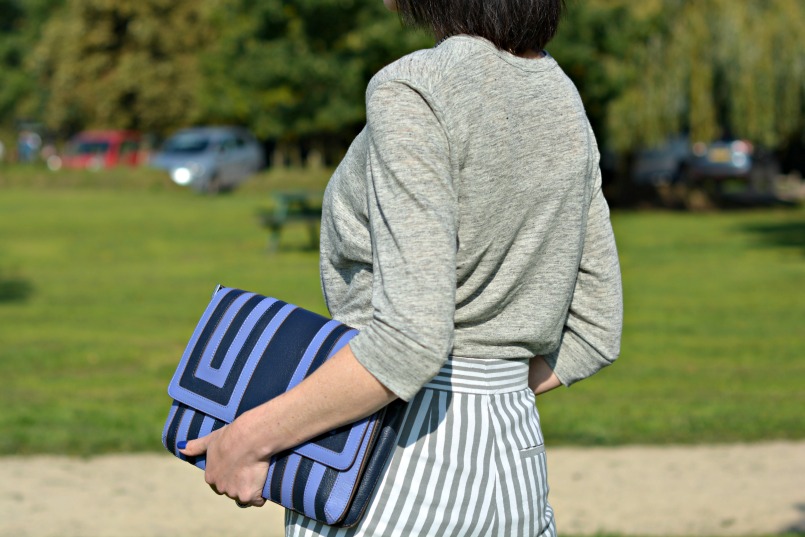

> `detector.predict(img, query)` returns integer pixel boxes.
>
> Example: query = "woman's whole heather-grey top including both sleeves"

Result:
[321,36,623,400]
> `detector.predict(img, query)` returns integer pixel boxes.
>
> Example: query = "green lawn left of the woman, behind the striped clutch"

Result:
[0,166,326,453]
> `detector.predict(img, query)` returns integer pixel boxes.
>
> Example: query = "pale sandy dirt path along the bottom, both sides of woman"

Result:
[0,442,805,537]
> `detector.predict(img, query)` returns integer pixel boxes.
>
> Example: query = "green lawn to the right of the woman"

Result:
[539,205,805,444]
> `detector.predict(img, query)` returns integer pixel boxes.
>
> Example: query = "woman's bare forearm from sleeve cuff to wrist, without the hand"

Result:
[237,345,396,456]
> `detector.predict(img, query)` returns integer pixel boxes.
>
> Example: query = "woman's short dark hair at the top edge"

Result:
[397,0,565,53]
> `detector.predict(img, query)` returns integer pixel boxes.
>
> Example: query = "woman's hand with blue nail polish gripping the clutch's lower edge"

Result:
[179,418,268,507]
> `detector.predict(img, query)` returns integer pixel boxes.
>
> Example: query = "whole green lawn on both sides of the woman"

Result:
[0,168,805,454]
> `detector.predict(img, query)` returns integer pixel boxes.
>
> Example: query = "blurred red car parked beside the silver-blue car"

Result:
[61,130,144,169]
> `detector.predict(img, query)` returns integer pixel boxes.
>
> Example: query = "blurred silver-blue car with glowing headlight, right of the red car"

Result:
[151,127,265,193]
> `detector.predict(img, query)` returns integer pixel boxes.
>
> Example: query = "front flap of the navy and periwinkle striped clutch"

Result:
[168,286,364,470]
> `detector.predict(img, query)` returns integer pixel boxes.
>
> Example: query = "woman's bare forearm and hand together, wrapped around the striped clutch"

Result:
[181,345,396,506]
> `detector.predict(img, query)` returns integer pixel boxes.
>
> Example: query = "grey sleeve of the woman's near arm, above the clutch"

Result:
[350,81,458,400]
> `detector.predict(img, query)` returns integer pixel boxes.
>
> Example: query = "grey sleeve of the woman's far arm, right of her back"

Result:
[545,171,623,386]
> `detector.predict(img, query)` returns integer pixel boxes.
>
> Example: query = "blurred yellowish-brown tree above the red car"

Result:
[30,0,211,133]
